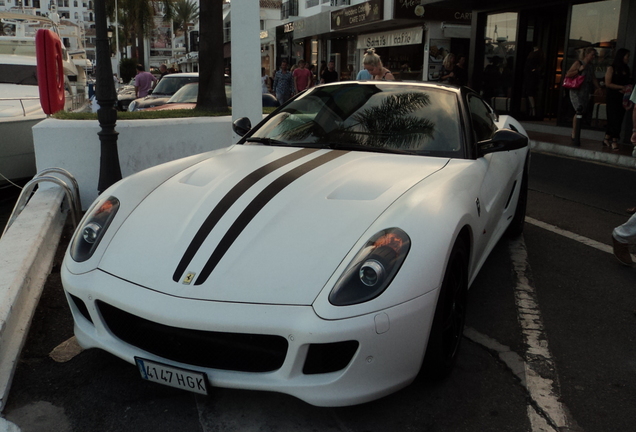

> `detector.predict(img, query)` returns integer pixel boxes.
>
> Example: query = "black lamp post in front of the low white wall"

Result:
[94,0,122,193]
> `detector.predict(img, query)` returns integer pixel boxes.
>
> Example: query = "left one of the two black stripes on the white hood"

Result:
[172,148,317,282]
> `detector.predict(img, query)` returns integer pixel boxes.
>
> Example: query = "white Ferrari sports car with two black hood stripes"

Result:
[62,81,530,406]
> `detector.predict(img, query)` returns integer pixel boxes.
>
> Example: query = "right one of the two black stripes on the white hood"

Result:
[194,150,348,285]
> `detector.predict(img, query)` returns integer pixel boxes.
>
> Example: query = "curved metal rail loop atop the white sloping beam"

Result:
[2,168,81,235]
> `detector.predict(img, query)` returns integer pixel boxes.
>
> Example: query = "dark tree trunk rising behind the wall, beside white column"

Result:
[196,0,228,112]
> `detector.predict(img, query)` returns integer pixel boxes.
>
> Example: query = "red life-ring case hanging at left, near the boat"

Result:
[35,29,65,114]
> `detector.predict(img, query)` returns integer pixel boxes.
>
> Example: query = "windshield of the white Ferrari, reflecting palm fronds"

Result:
[247,83,463,157]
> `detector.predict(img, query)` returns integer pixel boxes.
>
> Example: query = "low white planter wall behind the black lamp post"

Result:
[33,115,236,210]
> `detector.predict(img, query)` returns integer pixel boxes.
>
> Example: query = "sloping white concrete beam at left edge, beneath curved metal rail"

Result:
[0,186,66,412]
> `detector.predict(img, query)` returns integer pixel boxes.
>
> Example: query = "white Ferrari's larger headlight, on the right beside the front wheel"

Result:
[329,228,411,306]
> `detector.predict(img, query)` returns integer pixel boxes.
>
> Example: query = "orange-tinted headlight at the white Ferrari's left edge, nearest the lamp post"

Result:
[71,197,119,262]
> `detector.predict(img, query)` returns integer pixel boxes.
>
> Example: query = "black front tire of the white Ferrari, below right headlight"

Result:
[421,238,468,380]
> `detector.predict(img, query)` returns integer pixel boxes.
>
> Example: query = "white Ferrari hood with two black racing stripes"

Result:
[99,145,448,305]
